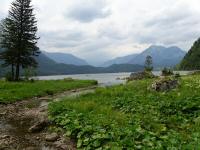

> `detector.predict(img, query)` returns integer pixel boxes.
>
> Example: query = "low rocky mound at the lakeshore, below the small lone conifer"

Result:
[128,71,156,81]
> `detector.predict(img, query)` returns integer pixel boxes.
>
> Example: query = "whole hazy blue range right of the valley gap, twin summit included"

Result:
[102,45,186,68]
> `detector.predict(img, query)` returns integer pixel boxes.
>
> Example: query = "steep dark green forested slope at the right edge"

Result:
[180,38,200,70]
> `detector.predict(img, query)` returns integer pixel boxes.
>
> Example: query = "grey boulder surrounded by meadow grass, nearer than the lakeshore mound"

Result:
[151,79,179,92]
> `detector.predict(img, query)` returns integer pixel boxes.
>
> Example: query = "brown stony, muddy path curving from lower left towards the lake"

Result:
[0,87,96,150]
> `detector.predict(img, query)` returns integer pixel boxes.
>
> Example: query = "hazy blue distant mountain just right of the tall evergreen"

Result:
[43,51,88,66]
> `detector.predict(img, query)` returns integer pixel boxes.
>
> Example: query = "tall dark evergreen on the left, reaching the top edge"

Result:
[0,0,40,80]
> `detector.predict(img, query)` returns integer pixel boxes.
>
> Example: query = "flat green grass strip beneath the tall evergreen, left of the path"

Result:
[0,80,96,103]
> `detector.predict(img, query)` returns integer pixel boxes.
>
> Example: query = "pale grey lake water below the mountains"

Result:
[37,71,189,86]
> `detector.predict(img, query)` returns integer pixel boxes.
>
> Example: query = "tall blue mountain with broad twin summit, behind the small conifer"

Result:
[129,46,186,68]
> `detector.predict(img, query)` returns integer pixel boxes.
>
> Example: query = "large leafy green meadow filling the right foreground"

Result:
[49,75,200,150]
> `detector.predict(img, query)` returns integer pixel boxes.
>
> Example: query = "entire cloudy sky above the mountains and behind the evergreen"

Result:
[0,0,200,65]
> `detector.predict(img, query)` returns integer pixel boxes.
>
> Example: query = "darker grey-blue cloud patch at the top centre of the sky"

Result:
[66,0,110,23]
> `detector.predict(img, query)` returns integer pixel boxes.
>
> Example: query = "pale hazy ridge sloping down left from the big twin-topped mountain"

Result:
[102,54,138,67]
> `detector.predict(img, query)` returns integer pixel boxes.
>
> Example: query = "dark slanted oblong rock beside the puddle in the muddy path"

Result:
[29,119,49,133]
